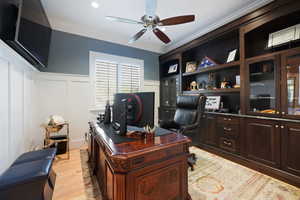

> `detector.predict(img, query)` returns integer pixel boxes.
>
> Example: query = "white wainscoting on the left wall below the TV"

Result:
[0,40,39,174]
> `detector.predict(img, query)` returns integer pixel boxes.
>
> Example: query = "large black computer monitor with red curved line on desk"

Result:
[113,92,155,127]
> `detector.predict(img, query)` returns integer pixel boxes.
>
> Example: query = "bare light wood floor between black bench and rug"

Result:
[53,149,87,200]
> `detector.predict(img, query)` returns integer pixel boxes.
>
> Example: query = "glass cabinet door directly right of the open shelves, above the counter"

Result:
[248,58,280,115]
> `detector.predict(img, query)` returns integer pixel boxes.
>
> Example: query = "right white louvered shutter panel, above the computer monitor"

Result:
[118,64,142,93]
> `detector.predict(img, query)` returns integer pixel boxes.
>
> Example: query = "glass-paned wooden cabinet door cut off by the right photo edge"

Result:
[281,50,300,119]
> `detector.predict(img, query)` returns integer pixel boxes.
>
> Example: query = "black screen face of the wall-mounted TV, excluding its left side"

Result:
[15,0,52,67]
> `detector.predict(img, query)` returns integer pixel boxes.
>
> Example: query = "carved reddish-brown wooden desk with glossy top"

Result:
[89,123,191,200]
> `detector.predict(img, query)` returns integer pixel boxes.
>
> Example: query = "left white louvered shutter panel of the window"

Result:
[95,60,118,108]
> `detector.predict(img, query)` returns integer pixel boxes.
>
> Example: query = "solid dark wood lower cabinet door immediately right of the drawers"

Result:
[245,119,280,167]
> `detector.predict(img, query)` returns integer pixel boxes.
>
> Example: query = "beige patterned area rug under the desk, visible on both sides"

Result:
[80,147,300,200]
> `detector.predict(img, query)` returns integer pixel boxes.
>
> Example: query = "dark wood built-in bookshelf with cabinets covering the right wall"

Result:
[160,0,300,186]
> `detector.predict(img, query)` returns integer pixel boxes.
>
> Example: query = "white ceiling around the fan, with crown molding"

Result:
[42,0,273,53]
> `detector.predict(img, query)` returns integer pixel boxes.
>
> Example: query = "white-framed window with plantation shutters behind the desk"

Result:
[90,52,144,109]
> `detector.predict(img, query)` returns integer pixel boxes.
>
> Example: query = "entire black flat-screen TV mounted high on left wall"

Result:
[0,0,52,68]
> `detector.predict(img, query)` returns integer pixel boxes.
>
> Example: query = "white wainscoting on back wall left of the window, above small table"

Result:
[36,73,91,148]
